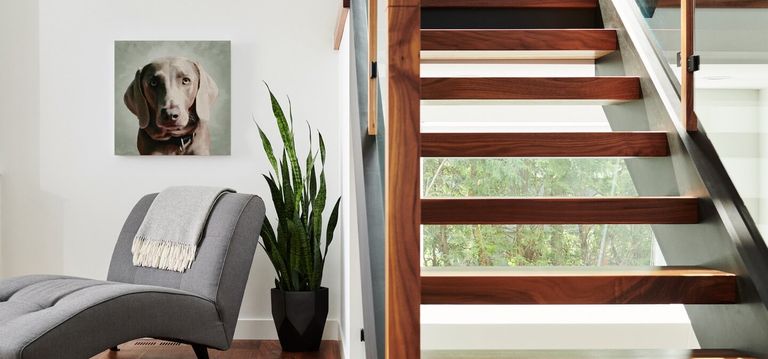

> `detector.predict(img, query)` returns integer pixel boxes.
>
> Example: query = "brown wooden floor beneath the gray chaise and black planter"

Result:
[91,339,341,359]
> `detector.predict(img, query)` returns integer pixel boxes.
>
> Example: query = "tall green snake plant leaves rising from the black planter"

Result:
[257,86,341,291]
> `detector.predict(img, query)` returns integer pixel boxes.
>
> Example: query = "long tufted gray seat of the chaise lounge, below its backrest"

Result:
[0,275,228,359]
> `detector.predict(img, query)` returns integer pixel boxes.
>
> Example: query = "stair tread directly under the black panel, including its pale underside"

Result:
[421,29,618,62]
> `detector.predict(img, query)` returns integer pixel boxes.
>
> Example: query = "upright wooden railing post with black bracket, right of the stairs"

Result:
[680,0,699,132]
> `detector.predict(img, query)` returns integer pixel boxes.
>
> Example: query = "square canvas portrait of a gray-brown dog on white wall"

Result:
[115,41,231,155]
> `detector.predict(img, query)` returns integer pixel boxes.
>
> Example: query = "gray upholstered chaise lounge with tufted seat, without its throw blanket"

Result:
[0,193,264,359]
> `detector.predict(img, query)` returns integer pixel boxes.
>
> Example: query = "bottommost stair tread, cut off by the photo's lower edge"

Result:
[421,349,753,359]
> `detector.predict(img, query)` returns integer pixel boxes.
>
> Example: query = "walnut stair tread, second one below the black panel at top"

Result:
[421,76,641,101]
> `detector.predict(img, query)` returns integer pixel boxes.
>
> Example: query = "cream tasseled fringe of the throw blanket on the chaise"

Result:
[131,236,197,273]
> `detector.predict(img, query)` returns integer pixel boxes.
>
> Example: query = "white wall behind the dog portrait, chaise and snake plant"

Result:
[0,0,346,337]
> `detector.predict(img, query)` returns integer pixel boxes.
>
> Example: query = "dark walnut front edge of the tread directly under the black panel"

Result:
[421,29,618,51]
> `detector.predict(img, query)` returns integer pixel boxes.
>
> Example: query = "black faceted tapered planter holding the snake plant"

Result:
[272,287,328,352]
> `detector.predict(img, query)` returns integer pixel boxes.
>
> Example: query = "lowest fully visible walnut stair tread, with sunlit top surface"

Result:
[421,267,737,304]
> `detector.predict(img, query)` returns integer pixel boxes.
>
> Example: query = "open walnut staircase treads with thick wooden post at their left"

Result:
[386,0,760,359]
